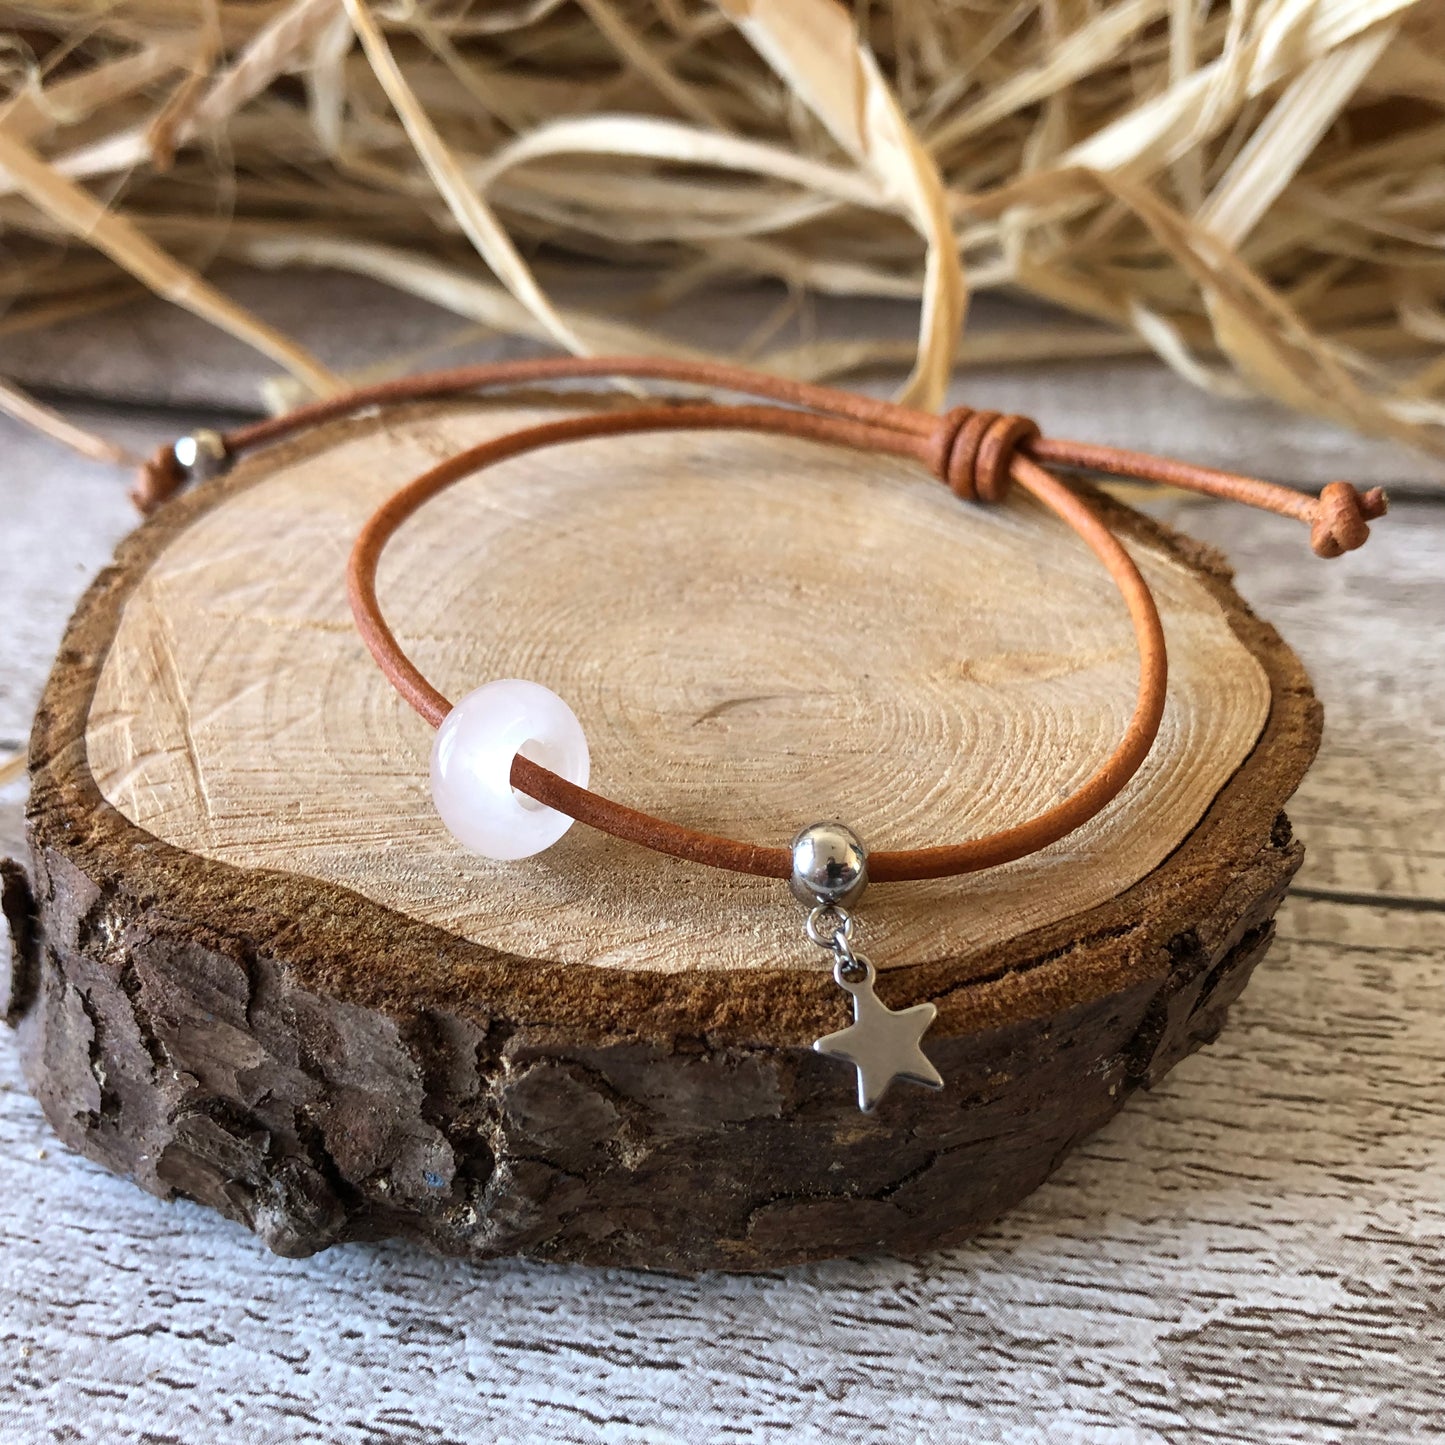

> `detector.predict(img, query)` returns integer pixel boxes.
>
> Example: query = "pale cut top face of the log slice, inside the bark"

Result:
[85,406,1270,971]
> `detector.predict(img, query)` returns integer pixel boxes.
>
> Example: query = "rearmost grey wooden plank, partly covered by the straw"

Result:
[0,266,1445,488]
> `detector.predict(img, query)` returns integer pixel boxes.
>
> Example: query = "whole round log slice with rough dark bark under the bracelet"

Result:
[6,396,1319,1270]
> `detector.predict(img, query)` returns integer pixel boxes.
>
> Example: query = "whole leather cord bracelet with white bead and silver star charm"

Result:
[134,357,1386,1111]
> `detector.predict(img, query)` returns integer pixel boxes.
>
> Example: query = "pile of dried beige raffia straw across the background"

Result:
[0,0,1445,452]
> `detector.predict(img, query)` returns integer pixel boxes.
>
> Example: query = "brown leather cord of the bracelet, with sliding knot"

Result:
[137,357,1386,883]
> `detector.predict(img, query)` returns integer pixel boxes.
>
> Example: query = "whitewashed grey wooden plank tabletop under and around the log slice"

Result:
[0,284,1445,1445]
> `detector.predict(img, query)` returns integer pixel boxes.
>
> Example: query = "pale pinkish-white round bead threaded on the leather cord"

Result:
[432,678,591,860]
